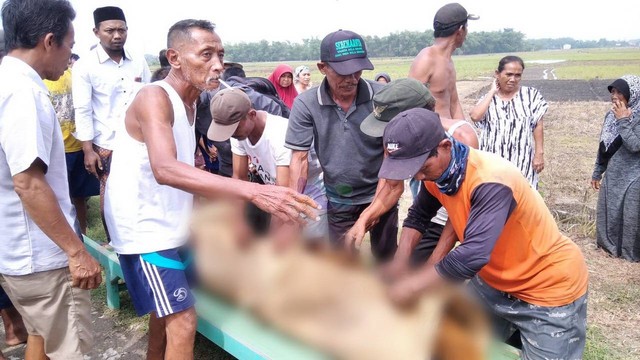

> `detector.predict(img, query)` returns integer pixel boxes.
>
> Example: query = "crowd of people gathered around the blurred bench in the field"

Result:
[0,0,640,359]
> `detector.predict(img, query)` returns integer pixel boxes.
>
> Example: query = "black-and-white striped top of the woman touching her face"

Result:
[475,86,549,189]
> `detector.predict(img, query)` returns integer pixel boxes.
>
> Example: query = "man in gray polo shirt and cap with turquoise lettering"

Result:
[285,30,398,261]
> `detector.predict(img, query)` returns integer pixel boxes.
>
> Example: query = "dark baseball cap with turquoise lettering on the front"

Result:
[320,29,373,75]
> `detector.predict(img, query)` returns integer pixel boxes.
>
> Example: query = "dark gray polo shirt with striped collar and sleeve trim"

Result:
[285,79,383,205]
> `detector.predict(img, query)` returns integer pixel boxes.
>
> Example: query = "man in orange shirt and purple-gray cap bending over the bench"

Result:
[379,109,588,359]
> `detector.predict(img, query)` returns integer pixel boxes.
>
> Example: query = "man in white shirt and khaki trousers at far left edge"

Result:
[0,0,102,359]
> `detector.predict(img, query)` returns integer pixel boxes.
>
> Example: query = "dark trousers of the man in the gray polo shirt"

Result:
[327,201,398,261]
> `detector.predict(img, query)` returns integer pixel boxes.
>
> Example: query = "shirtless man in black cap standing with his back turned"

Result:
[409,3,479,119]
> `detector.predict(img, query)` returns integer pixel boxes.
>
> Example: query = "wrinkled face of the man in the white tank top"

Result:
[176,28,224,91]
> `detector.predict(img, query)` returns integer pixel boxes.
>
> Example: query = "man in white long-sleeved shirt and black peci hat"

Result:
[72,6,151,232]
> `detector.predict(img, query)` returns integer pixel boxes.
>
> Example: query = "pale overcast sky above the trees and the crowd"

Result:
[65,0,640,56]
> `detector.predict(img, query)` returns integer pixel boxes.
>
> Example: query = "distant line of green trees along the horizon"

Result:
[148,28,633,63]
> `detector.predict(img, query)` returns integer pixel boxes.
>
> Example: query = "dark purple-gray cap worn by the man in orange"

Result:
[378,108,447,180]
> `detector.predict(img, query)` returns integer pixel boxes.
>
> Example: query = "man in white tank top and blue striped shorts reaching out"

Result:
[105,20,316,360]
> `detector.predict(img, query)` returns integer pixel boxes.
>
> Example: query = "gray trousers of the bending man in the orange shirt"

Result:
[469,275,588,360]
